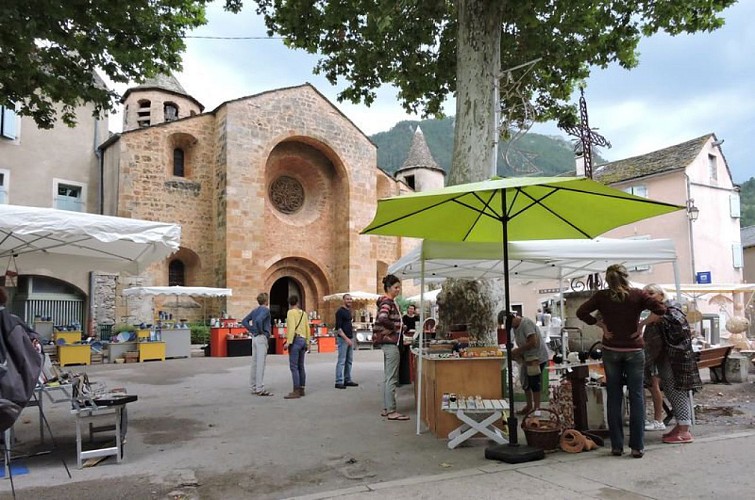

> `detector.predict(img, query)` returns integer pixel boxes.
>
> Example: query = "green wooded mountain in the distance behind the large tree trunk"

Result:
[370,117,605,177]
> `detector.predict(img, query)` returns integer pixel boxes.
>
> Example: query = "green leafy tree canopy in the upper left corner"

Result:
[0,0,239,128]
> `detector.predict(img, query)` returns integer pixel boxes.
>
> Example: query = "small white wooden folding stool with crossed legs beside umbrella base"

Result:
[441,399,509,449]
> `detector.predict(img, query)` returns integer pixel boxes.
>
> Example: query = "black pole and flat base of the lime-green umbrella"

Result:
[485,189,545,464]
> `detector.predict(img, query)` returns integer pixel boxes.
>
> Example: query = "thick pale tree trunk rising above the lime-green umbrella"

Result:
[447,0,505,186]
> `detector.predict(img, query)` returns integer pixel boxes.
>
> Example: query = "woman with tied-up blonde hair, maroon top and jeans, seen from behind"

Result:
[577,264,666,458]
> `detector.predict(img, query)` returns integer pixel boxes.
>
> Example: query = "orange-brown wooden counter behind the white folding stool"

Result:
[412,353,504,439]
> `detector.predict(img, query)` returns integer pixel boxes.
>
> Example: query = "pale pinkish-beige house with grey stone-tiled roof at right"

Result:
[512,134,744,334]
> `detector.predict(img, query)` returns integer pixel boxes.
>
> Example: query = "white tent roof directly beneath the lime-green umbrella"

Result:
[388,238,676,279]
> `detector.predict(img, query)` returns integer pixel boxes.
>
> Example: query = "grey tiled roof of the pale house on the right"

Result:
[593,134,715,185]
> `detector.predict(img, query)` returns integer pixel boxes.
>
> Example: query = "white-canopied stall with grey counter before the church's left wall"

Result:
[123,286,232,358]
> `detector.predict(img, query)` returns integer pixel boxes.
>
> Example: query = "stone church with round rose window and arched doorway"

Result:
[101,76,444,321]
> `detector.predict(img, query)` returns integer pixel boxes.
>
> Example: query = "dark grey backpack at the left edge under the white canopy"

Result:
[0,308,42,432]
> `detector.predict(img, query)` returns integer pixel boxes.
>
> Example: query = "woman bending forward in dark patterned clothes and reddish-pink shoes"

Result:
[644,284,702,444]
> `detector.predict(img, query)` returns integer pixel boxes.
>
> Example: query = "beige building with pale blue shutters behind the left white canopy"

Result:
[0,85,108,324]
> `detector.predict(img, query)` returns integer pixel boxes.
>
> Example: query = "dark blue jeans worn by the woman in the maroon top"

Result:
[603,349,645,450]
